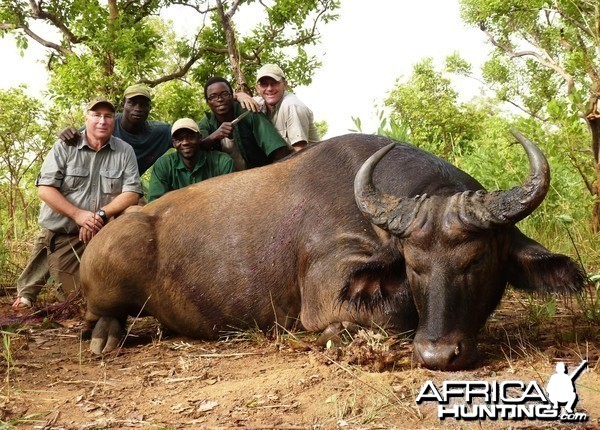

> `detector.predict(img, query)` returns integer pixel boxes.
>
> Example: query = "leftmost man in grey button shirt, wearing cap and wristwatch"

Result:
[13,98,142,309]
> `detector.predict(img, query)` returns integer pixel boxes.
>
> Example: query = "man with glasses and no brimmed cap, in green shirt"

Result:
[199,77,292,170]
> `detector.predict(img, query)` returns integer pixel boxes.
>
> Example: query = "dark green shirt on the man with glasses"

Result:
[198,101,287,169]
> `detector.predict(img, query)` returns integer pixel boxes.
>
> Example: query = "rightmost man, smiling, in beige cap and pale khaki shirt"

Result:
[236,64,321,151]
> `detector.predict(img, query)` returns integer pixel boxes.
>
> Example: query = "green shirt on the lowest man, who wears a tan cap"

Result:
[148,151,233,202]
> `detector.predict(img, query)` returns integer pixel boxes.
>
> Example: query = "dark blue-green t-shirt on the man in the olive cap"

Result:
[113,113,171,176]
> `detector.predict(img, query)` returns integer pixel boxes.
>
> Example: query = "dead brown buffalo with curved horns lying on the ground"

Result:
[81,132,584,370]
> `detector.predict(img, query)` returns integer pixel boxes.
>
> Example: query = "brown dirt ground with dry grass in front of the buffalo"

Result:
[0,293,600,429]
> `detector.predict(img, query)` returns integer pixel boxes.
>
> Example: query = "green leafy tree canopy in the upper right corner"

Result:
[461,0,600,232]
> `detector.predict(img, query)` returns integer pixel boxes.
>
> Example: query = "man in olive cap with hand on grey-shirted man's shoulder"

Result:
[60,84,171,175]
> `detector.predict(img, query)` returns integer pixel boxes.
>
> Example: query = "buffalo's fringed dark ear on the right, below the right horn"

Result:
[508,230,585,294]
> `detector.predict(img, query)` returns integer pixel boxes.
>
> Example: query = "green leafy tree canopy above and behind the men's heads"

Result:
[0,0,340,116]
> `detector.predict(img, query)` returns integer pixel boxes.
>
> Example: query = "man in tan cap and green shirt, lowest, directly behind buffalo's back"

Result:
[148,118,233,201]
